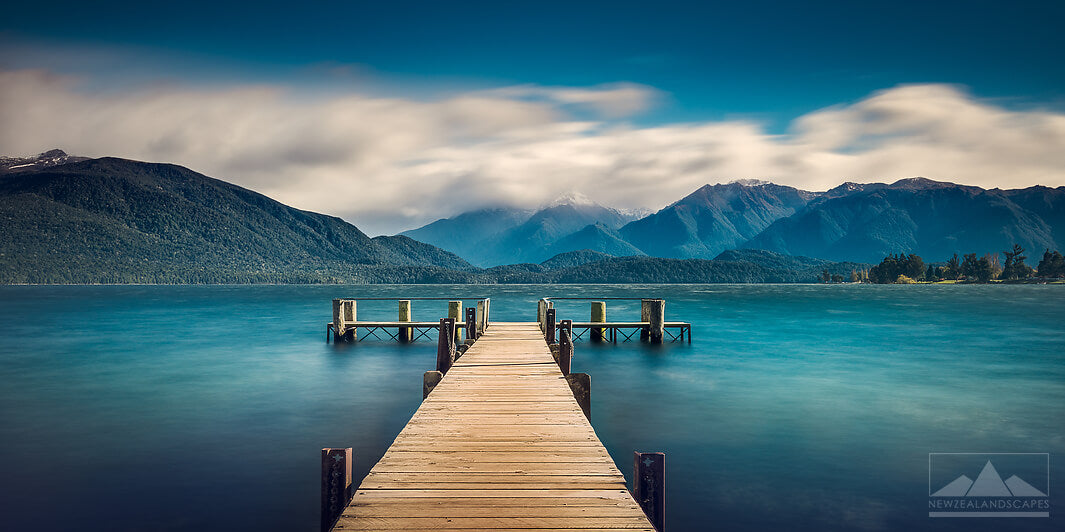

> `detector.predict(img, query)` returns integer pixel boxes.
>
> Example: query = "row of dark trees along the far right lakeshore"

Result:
[843,244,1065,284]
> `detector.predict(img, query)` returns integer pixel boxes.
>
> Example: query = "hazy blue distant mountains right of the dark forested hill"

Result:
[403,178,1065,266]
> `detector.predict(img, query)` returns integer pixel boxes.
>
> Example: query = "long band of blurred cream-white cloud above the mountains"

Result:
[0,70,1065,234]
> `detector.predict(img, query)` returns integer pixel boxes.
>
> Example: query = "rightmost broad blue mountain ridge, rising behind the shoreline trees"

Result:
[743,178,1065,262]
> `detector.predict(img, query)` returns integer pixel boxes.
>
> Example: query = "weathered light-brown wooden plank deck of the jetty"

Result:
[333,322,654,532]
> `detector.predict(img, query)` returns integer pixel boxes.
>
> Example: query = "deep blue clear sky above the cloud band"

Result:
[2,1,1065,126]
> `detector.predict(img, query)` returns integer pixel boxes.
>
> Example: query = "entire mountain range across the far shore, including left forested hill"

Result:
[0,150,1065,283]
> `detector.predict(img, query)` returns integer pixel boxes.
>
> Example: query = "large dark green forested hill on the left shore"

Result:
[0,157,471,283]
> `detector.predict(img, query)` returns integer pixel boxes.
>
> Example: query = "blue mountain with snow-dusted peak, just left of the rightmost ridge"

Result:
[619,183,815,259]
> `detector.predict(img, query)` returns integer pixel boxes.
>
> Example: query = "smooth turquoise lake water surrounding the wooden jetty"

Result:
[0,285,1065,531]
